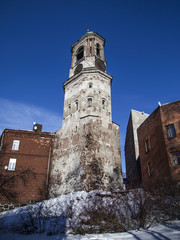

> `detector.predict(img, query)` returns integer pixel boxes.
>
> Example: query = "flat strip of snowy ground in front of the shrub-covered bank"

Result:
[0,221,180,240]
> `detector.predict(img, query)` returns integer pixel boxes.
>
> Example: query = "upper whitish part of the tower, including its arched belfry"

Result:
[63,32,112,128]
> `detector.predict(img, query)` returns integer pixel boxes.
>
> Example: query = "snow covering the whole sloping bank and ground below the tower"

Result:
[0,190,180,240]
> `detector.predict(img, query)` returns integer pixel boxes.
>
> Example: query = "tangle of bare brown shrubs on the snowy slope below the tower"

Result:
[73,190,155,234]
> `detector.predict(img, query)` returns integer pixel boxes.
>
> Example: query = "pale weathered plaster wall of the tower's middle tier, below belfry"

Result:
[63,70,112,126]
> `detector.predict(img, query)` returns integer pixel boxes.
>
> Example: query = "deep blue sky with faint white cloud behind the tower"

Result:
[0,0,180,170]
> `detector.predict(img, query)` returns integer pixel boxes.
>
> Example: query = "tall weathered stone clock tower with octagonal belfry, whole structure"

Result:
[50,31,123,196]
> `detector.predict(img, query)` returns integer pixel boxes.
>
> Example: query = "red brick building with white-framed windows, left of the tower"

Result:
[0,126,54,206]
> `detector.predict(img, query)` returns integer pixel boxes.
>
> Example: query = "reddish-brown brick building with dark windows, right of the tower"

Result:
[137,101,180,187]
